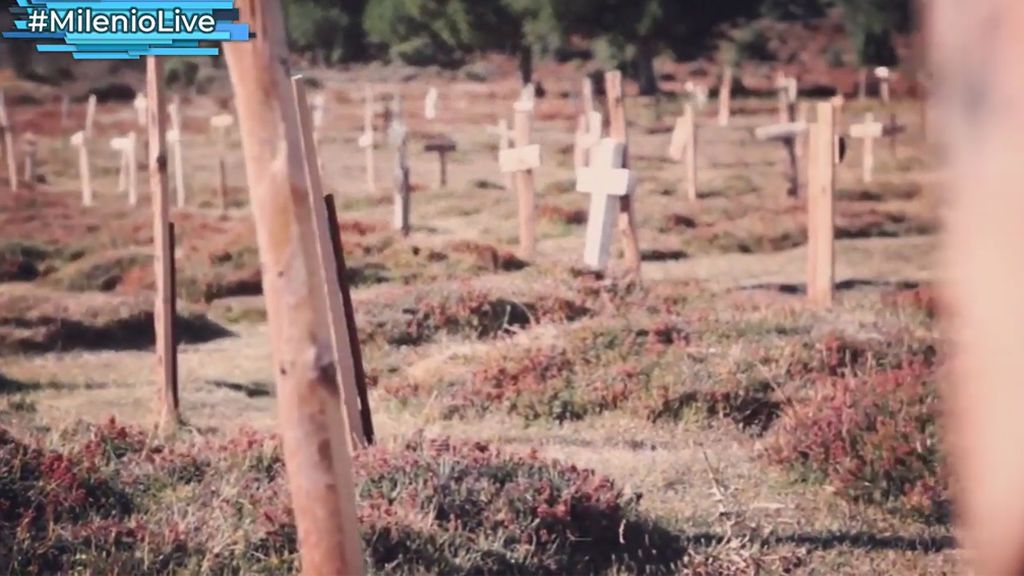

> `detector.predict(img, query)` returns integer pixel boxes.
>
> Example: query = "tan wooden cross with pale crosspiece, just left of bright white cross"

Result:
[499,99,541,260]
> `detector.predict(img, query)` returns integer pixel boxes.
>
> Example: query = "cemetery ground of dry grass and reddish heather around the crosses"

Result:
[0,60,958,574]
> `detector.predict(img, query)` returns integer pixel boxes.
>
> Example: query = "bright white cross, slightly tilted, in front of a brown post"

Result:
[577,138,636,272]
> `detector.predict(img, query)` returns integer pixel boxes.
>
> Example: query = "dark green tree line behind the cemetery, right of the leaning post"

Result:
[285,0,915,91]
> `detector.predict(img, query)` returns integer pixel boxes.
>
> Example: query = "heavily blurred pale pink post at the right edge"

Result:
[929,0,1024,576]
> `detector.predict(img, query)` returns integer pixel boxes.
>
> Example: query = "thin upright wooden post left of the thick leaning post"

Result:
[145,56,180,431]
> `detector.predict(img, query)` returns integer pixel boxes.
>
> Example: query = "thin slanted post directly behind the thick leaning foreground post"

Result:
[292,76,368,450]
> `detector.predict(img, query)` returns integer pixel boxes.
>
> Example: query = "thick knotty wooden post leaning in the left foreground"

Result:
[223,0,364,575]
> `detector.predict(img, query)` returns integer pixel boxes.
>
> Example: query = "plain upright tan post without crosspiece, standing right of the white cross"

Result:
[807,102,836,307]
